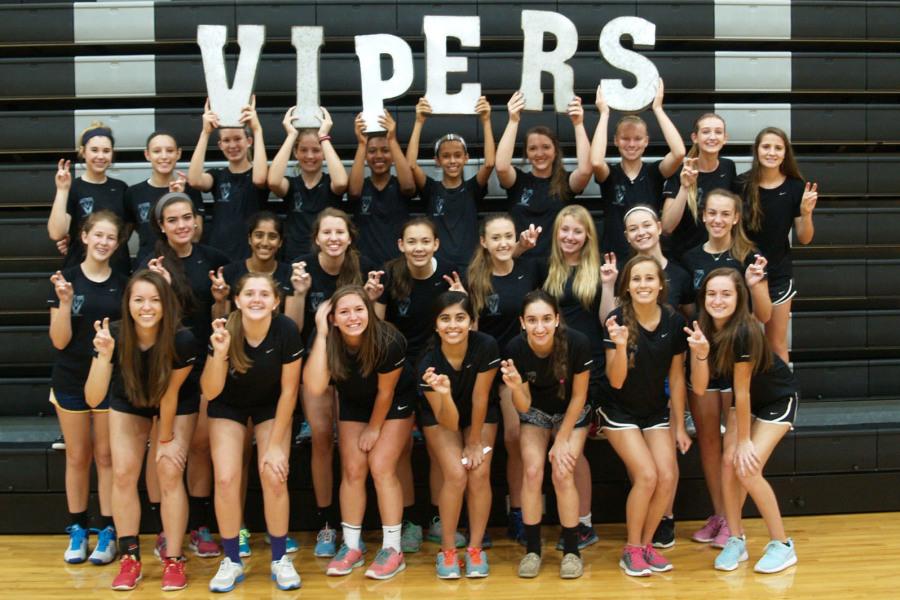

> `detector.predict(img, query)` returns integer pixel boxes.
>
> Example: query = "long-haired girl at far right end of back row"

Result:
[741,127,819,362]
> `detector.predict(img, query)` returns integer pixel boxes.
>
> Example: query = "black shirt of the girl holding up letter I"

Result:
[281,173,343,256]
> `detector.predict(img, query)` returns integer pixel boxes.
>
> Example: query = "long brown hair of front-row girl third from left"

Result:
[325,285,406,381]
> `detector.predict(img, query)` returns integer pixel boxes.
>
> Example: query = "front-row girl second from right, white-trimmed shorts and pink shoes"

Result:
[598,256,708,576]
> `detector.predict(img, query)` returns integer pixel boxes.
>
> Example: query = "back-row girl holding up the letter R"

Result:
[496,92,591,258]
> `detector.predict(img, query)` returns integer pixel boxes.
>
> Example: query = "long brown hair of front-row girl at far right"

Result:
[697,268,773,377]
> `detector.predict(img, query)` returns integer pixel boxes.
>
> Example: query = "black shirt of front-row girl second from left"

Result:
[208,314,304,408]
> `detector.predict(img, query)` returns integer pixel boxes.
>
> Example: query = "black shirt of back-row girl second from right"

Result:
[663,157,741,259]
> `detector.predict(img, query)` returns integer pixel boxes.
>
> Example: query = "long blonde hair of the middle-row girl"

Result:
[544,204,600,310]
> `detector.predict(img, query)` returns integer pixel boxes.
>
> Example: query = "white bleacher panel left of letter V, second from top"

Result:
[75,54,156,98]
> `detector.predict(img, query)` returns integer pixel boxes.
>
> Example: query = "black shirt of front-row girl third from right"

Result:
[504,328,594,415]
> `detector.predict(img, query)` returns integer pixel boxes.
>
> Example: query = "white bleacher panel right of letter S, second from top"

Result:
[716,52,792,92]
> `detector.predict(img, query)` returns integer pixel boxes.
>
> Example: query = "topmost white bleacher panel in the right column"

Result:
[715,0,791,40]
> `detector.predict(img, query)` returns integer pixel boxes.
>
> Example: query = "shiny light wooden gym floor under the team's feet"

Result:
[0,513,900,600]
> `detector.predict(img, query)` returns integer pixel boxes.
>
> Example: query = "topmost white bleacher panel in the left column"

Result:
[72,0,156,44]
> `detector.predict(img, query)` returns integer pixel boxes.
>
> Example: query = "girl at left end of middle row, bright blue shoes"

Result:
[47,210,127,565]
